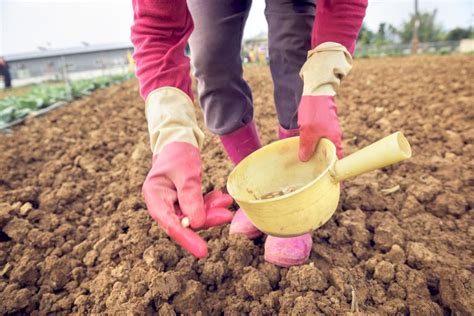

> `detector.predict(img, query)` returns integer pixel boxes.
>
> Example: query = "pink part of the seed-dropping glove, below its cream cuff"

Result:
[142,142,233,258]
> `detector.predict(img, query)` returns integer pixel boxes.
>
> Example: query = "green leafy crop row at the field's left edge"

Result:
[0,75,131,128]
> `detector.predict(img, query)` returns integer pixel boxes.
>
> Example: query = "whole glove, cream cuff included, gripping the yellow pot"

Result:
[298,42,352,161]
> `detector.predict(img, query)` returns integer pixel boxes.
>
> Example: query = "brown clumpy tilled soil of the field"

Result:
[0,55,474,315]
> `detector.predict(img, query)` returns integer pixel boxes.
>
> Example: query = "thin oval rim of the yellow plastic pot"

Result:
[226,136,337,204]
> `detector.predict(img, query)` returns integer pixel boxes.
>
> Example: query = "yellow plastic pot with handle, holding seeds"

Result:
[227,132,411,237]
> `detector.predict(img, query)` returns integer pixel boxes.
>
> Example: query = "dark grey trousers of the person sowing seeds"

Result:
[188,0,315,135]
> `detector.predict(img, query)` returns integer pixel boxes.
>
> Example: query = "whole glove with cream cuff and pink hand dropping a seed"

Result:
[143,87,233,258]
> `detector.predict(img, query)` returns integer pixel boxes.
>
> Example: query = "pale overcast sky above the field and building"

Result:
[0,0,474,55]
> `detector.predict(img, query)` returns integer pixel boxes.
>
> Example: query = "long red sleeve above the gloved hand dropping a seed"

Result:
[131,0,193,99]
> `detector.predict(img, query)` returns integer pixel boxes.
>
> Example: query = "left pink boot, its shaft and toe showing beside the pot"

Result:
[220,122,262,239]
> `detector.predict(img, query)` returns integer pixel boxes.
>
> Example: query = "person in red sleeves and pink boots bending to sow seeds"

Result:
[132,0,367,267]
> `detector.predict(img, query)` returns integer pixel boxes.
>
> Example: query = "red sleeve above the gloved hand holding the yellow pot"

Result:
[312,0,368,54]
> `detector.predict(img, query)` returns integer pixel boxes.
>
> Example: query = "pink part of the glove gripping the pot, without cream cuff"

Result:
[298,95,343,161]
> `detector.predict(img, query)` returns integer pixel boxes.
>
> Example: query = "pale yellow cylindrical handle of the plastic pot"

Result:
[331,132,411,182]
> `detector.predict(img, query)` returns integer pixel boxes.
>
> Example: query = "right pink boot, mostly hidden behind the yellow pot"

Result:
[265,126,313,268]
